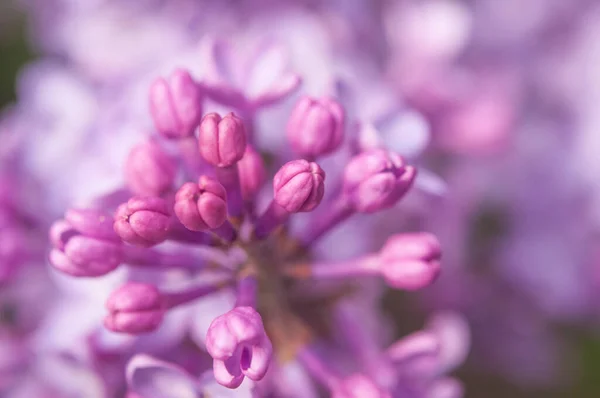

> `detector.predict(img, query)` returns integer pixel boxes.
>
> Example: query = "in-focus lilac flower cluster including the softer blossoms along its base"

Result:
[42,48,465,397]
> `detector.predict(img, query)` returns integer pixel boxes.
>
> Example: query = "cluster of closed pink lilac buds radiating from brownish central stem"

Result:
[50,64,448,398]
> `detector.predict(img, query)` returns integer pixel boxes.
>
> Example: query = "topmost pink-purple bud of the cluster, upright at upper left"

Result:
[150,69,202,138]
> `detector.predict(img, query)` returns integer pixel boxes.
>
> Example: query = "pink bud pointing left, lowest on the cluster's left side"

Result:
[104,282,165,334]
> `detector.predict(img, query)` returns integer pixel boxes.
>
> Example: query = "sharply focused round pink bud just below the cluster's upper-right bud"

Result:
[273,160,325,213]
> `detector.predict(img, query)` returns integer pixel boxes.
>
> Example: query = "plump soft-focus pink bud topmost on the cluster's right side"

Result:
[287,96,344,159]
